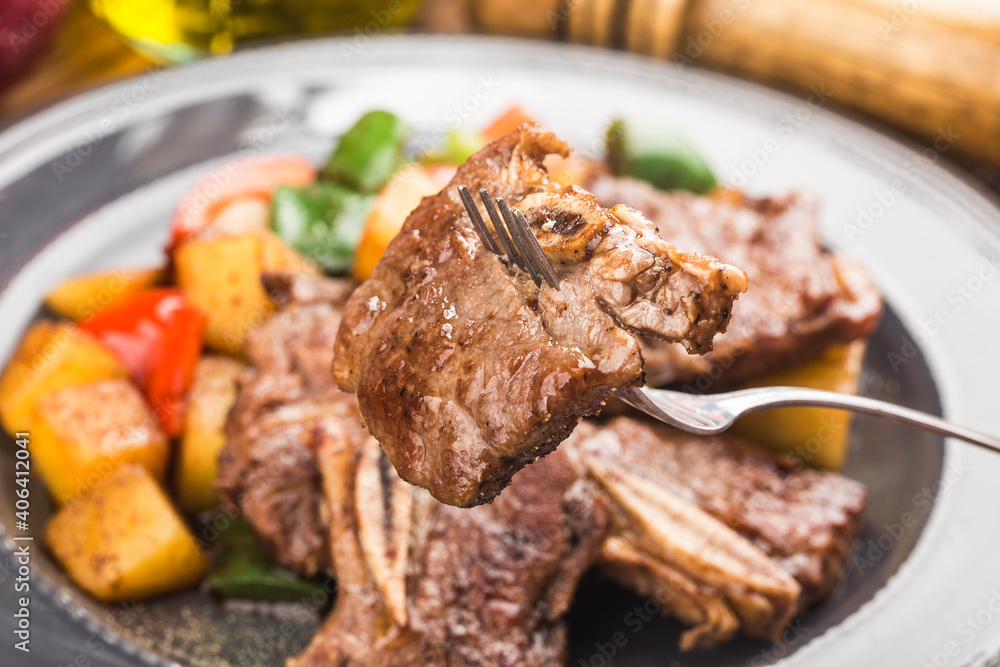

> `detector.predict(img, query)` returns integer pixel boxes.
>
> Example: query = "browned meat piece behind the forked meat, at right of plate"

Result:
[587,174,882,391]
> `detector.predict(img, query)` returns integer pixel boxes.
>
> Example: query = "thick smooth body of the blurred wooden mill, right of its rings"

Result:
[684,0,1000,164]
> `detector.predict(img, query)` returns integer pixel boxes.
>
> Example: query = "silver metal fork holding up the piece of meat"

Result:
[458,185,1000,452]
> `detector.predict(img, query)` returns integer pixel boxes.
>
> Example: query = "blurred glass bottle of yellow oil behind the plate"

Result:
[90,0,421,62]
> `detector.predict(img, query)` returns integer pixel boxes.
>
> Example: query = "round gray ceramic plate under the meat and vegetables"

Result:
[0,37,1000,667]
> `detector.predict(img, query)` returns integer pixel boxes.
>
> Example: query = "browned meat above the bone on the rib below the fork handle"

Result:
[566,417,867,608]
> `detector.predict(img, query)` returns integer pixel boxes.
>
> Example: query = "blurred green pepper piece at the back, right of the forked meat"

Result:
[606,120,717,194]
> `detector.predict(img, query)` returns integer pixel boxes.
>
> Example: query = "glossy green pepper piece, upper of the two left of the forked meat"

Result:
[320,111,410,192]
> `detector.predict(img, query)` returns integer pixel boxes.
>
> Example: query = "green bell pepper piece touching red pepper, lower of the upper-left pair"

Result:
[271,183,375,273]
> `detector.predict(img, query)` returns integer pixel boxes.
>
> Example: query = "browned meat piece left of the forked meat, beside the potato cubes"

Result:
[216,274,358,575]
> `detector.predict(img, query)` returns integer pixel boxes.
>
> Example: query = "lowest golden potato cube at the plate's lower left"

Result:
[45,464,208,602]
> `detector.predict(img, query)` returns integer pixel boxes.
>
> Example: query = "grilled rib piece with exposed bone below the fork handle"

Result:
[564,417,866,649]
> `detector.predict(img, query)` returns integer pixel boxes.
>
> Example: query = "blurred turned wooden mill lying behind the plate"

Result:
[472,0,1000,165]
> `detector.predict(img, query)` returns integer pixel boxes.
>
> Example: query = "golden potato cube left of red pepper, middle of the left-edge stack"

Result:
[31,378,170,504]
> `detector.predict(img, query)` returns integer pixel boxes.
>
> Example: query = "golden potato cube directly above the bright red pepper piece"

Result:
[174,234,274,354]
